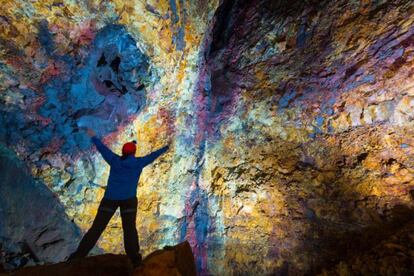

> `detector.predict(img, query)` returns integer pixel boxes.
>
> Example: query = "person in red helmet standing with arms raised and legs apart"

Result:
[67,128,168,266]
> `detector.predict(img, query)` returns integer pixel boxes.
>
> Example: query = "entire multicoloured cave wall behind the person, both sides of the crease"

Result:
[0,0,414,275]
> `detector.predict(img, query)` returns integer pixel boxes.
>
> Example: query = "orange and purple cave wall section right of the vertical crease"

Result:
[196,1,414,274]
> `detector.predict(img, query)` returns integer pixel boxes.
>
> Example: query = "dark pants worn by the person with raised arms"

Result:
[69,197,141,264]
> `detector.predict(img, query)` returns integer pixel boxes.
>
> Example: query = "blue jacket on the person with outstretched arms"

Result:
[91,136,168,200]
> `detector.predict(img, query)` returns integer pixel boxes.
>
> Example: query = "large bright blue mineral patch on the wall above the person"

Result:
[2,21,150,153]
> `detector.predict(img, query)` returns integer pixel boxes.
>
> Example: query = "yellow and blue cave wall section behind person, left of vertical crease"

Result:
[0,0,218,268]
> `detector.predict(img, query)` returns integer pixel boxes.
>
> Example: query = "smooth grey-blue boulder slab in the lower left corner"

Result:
[0,144,88,270]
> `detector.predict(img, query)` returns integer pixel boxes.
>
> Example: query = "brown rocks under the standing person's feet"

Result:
[0,242,197,276]
